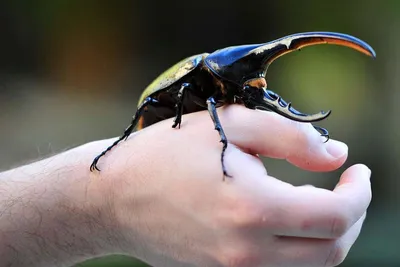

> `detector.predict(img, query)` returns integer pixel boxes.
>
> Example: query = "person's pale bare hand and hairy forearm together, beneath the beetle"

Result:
[0,106,371,267]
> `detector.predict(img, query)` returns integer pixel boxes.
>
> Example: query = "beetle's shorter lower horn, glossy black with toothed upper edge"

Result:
[253,90,331,122]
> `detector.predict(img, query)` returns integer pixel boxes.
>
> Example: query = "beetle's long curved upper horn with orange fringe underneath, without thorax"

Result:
[248,32,376,71]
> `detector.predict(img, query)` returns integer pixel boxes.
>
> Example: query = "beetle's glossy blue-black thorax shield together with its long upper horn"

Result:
[205,32,375,84]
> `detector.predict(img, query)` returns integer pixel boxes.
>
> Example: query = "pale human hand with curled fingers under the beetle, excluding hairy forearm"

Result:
[95,105,371,267]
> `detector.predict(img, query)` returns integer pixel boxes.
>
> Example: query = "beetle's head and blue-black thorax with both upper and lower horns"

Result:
[205,32,375,122]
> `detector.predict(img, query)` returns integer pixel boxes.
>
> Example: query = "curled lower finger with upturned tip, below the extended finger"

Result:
[262,164,372,238]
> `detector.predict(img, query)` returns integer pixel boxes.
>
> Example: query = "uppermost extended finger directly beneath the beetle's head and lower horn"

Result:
[218,105,348,171]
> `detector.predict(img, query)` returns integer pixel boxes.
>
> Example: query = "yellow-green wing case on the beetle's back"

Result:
[138,53,208,105]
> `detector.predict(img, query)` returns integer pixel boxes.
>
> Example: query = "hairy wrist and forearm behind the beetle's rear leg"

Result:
[0,141,124,266]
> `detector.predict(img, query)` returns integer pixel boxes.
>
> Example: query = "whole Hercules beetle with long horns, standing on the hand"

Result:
[90,32,375,177]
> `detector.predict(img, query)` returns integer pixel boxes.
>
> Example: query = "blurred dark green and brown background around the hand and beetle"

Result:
[0,0,400,267]
